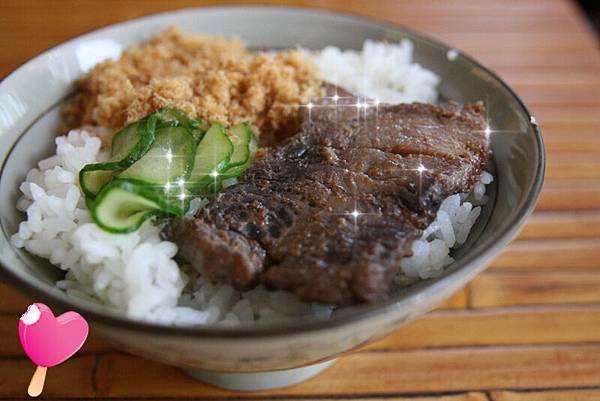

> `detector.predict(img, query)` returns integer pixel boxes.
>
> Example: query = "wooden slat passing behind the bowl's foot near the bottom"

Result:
[96,345,600,398]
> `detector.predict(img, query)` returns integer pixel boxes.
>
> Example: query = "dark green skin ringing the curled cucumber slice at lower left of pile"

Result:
[90,179,185,234]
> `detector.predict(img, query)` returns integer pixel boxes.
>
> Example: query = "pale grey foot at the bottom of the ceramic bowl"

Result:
[184,359,335,391]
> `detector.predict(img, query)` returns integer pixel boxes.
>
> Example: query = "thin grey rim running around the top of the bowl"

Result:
[0,5,546,339]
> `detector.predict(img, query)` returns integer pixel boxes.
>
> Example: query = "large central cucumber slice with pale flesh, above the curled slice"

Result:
[117,127,196,185]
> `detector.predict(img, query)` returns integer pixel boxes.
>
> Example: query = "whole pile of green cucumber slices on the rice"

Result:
[80,108,258,233]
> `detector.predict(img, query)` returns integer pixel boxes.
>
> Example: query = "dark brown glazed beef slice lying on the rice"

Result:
[166,98,489,305]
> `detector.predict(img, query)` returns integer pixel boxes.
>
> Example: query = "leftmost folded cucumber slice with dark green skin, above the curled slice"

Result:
[79,115,157,198]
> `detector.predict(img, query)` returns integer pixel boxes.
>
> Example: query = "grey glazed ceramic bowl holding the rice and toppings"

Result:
[0,7,544,389]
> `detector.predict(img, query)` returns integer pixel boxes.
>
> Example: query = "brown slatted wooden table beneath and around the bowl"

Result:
[0,0,600,401]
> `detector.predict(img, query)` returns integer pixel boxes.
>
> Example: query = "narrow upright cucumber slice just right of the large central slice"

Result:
[187,124,233,192]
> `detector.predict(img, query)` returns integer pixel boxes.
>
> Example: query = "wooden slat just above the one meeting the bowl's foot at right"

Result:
[368,306,600,350]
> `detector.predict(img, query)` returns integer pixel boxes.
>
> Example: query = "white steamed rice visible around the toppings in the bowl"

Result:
[12,40,493,325]
